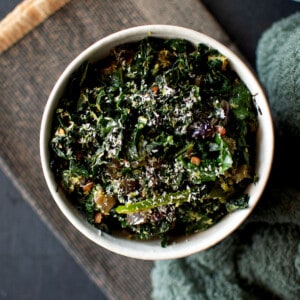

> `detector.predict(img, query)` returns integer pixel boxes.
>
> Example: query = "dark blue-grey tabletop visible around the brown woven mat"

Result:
[0,0,300,300]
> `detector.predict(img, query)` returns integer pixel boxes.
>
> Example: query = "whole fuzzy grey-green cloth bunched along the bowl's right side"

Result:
[151,13,300,300]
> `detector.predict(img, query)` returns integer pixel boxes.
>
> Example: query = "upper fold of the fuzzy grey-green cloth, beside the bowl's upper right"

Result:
[257,12,300,137]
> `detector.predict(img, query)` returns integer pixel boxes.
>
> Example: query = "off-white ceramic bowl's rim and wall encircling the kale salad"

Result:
[40,25,274,260]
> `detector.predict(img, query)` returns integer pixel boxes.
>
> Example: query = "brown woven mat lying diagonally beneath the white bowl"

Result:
[0,0,232,299]
